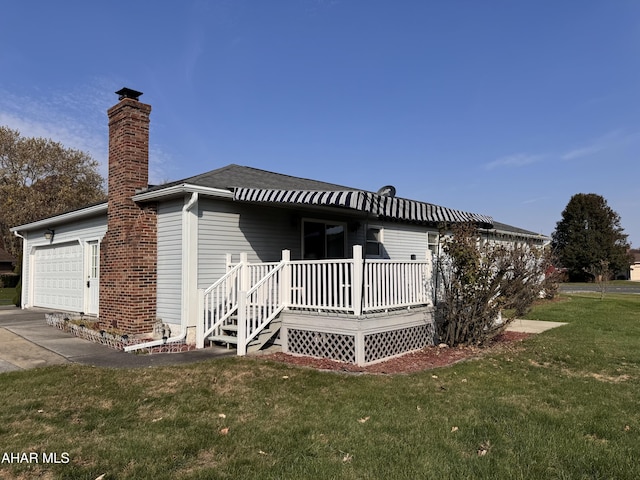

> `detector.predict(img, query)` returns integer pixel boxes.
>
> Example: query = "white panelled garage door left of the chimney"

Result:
[34,243,84,312]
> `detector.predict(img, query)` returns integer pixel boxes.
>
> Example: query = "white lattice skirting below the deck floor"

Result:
[282,308,435,365]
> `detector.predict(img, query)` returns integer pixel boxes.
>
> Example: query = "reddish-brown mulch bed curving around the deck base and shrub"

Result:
[265,332,532,374]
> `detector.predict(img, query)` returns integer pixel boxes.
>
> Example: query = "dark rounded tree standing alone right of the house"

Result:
[552,193,630,281]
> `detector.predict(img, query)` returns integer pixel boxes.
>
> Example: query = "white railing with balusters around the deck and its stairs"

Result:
[197,245,433,355]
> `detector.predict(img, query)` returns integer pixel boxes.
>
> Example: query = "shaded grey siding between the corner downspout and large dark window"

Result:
[198,199,301,288]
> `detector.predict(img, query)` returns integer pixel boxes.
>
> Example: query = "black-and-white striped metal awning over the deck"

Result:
[234,188,493,228]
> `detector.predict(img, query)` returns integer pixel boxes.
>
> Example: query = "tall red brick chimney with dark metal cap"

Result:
[100,88,157,334]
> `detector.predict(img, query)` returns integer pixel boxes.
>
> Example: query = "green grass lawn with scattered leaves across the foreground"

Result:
[0,295,640,479]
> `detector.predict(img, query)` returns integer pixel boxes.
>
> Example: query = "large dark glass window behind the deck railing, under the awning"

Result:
[302,220,346,259]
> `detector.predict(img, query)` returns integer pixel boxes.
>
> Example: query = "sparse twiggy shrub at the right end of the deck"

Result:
[436,225,554,346]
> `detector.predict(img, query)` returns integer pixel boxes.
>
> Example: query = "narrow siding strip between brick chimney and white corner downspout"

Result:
[156,199,183,325]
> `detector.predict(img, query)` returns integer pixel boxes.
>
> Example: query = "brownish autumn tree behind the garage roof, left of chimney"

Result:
[0,126,105,257]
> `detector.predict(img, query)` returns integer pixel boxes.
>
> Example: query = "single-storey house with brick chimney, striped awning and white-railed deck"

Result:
[12,89,548,364]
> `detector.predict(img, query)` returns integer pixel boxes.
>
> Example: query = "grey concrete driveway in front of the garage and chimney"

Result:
[0,307,234,373]
